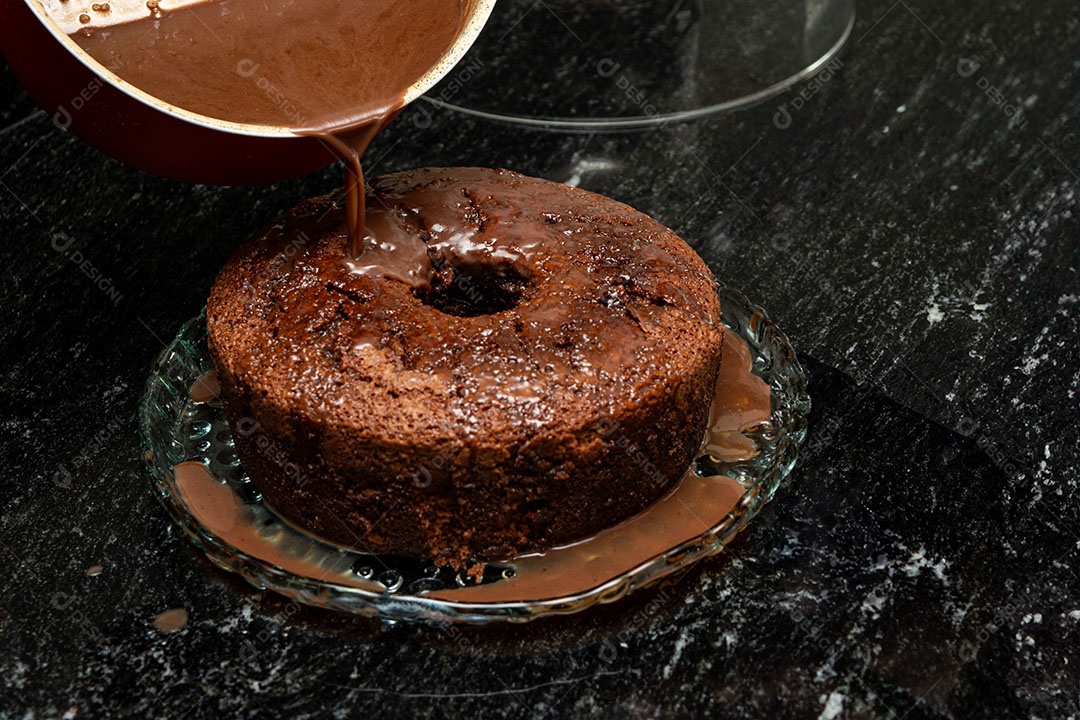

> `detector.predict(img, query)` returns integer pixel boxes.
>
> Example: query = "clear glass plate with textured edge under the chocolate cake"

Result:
[139,285,810,624]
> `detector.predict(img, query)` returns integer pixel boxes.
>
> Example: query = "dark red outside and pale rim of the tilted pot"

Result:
[0,0,495,185]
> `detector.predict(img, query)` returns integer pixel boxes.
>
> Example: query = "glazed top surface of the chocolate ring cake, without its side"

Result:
[210,168,723,444]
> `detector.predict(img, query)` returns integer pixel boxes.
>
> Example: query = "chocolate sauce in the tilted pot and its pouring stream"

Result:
[71,0,475,250]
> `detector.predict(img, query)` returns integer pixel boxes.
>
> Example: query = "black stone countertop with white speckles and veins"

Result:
[0,0,1080,720]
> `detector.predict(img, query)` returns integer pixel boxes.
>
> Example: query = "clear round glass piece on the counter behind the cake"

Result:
[426,0,855,130]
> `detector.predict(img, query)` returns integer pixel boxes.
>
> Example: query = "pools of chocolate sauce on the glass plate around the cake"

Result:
[181,331,771,602]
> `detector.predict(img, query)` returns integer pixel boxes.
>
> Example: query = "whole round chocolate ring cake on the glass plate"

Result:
[207,168,724,567]
